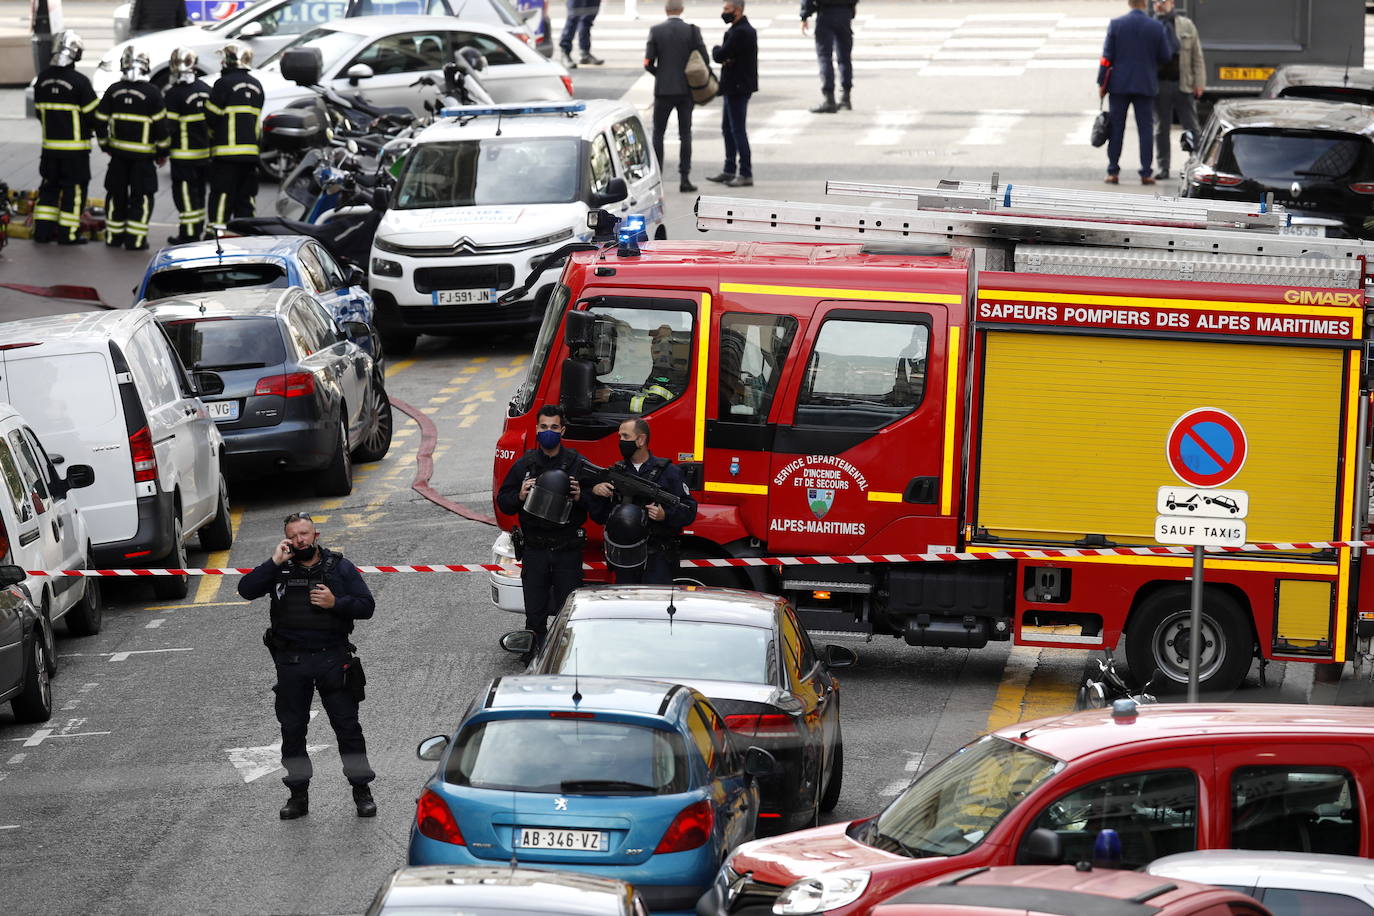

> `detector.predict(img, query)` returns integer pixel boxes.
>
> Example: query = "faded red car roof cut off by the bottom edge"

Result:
[874,865,1271,916]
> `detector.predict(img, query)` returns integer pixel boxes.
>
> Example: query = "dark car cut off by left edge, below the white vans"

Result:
[0,563,52,722]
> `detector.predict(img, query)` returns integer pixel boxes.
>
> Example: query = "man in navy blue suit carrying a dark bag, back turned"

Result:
[1098,0,1175,184]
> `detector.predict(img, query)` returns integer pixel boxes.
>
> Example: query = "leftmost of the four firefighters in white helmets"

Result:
[33,30,100,244]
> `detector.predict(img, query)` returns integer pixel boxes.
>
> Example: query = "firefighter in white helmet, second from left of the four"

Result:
[95,47,169,251]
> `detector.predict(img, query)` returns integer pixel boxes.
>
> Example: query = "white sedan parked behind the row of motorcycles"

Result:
[256,16,573,115]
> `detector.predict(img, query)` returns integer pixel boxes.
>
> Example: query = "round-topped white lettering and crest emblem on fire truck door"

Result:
[768,455,868,537]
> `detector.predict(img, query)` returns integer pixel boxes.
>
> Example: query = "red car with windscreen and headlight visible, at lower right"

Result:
[697,700,1374,916]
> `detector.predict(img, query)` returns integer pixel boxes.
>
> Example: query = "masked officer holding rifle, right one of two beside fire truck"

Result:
[587,417,697,585]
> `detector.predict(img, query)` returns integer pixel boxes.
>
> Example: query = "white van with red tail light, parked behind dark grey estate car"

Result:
[0,309,232,599]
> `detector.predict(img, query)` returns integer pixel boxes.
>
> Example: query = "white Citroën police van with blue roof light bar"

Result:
[370,99,665,354]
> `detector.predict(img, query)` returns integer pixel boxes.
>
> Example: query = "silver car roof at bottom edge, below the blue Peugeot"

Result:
[367,865,649,916]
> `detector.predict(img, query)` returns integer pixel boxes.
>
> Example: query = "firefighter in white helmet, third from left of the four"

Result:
[166,48,210,244]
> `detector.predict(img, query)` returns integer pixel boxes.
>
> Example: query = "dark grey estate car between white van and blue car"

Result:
[143,287,392,496]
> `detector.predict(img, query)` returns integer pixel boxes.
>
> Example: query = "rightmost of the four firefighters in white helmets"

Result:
[205,43,262,225]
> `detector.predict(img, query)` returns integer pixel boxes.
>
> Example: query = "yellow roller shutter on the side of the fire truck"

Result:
[976,331,1344,544]
